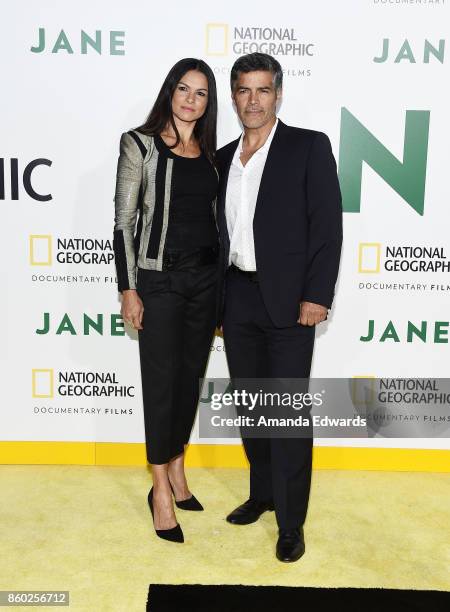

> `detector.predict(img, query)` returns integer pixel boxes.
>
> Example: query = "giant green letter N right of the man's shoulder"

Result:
[339,107,430,215]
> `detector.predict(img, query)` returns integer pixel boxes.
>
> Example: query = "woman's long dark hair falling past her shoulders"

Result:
[135,57,217,163]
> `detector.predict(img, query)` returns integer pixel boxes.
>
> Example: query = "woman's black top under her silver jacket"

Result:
[155,136,218,250]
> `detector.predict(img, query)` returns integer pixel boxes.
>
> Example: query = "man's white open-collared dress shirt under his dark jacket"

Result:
[225,119,278,271]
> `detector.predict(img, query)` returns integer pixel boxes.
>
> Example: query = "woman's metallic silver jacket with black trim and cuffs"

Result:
[113,130,216,291]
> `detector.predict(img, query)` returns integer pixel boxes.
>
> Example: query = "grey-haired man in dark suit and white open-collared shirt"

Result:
[217,53,342,562]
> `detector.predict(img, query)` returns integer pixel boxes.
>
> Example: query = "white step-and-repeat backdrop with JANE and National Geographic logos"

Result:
[0,0,450,448]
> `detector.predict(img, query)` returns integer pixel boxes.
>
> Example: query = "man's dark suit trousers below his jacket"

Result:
[223,268,315,529]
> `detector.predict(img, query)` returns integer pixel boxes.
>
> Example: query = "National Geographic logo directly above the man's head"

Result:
[205,23,314,57]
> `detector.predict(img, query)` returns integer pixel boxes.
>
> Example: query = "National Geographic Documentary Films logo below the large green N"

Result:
[358,242,450,291]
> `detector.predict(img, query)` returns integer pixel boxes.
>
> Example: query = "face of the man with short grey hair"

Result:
[232,70,281,128]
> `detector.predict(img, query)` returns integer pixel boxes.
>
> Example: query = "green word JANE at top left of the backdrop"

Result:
[30,28,125,55]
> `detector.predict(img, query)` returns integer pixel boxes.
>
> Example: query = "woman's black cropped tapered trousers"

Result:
[137,263,217,465]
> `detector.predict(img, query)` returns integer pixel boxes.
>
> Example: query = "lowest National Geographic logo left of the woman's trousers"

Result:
[31,368,135,399]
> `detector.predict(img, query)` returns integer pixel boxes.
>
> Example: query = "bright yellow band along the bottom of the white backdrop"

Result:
[0,441,450,472]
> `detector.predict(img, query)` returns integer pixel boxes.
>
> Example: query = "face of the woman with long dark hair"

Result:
[172,70,208,122]
